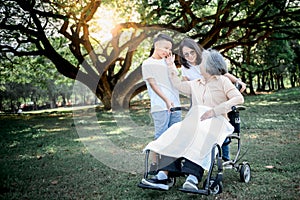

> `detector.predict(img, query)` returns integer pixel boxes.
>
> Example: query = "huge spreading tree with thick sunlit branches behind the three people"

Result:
[0,0,300,109]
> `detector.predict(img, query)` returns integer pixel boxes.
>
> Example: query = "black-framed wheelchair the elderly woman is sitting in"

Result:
[138,106,251,195]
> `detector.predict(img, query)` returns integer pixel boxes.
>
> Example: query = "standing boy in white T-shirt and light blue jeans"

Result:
[142,34,181,139]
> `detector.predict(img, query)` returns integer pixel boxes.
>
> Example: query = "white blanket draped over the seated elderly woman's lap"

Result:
[144,106,234,170]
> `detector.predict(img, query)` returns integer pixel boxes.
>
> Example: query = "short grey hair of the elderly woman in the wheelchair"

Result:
[202,49,228,75]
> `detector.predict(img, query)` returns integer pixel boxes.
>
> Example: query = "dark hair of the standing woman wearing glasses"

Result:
[179,38,203,69]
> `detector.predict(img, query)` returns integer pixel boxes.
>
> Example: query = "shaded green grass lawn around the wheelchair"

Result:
[0,88,300,200]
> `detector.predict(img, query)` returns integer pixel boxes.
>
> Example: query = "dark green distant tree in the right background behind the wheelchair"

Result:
[235,35,297,94]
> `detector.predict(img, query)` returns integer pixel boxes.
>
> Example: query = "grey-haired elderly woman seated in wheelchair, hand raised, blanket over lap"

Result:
[139,50,244,193]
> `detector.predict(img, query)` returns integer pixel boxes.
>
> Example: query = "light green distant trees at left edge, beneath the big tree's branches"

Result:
[0,41,73,111]
